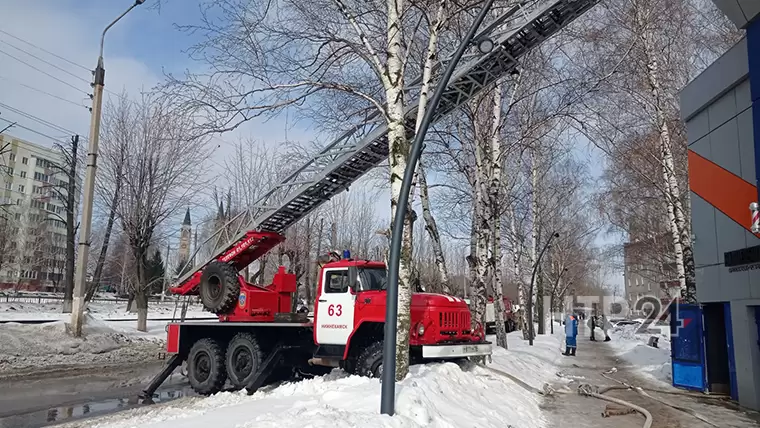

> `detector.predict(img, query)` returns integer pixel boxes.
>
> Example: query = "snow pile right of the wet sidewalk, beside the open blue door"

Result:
[608,324,672,382]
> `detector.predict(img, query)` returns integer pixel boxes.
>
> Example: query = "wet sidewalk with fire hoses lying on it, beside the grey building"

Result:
[542,325,760,428]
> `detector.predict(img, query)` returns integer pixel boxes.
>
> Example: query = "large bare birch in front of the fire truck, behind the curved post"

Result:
[163,0,476,379]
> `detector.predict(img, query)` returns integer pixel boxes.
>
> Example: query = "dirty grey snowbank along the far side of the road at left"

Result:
[0,315,165,373]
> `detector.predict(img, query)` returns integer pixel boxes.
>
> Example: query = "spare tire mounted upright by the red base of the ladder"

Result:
[200,261,240,314]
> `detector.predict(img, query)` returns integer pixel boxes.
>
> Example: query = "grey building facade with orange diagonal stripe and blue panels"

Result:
[680,0,760,410]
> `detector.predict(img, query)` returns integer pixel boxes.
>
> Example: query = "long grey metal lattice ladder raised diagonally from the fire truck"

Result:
[178,0,599,284]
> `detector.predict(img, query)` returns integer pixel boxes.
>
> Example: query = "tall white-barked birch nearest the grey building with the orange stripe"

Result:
[568,0,744,301]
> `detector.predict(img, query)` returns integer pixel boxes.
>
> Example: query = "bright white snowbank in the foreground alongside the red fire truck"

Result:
[59,332,561,428]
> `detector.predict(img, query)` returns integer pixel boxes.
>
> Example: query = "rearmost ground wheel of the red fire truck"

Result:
[187,339,227,395]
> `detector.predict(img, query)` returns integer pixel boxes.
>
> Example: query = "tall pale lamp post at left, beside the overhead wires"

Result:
[71,0,145,336]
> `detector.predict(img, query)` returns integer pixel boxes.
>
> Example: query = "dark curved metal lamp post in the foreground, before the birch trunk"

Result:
[380,0,493,415]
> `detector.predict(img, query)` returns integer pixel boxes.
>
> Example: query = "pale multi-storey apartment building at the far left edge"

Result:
[0,134,79,291]
